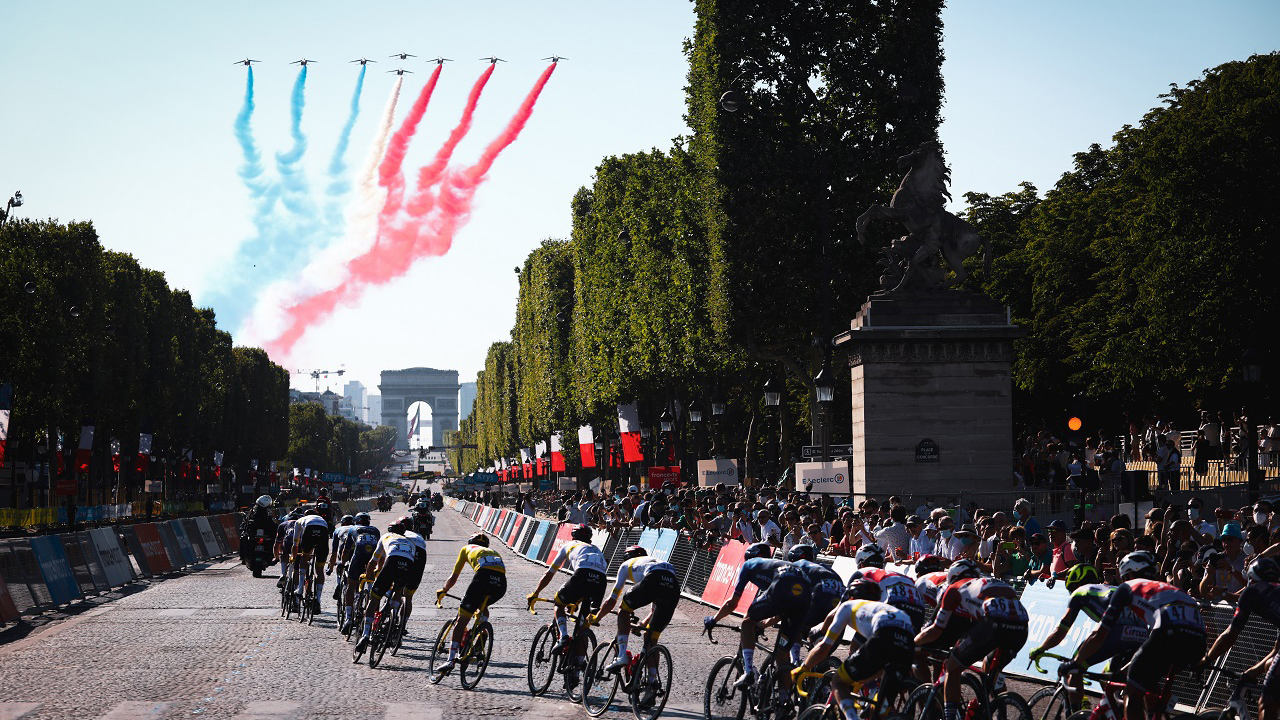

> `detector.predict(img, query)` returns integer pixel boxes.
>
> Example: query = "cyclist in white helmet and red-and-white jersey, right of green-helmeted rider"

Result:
[1075,551,1204,720]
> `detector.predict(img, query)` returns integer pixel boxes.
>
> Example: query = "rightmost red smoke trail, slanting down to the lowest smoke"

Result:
[265,63,556,359]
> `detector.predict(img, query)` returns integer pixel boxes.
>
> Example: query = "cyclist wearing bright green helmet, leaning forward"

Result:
[1029,564,1147,707]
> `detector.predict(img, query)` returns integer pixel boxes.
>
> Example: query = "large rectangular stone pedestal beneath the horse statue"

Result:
[836,292,1024,496]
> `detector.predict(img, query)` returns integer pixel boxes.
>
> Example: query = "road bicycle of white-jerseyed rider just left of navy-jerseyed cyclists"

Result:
[582,616,671,720]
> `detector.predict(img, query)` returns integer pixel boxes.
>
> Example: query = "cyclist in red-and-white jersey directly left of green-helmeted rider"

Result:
[915,559,1028,720]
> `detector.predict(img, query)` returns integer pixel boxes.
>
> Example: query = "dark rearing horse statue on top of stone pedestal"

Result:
[858,142,991,292]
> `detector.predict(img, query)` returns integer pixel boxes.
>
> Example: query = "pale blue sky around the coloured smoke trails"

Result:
[0,0,1280,404]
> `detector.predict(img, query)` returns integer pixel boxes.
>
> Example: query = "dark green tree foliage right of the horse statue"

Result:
[969,54,1280,407]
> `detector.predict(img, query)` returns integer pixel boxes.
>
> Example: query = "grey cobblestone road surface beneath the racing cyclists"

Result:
[0,506,730,720]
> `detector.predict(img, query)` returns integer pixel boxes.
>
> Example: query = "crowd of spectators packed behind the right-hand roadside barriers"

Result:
[465,486,1280,601]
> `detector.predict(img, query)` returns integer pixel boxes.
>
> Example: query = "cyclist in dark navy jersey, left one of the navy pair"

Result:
[703,542,812,694]
